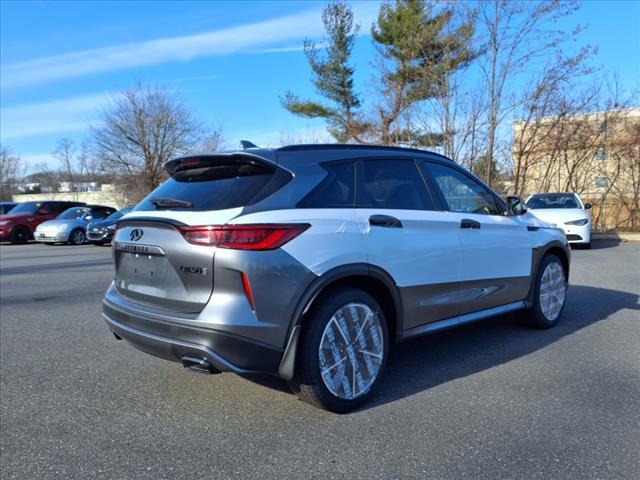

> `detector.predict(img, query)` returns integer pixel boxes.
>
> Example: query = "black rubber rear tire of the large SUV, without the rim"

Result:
[289,288,389,413]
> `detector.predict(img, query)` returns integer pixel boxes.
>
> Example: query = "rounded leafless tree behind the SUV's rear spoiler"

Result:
[90,84,220,197]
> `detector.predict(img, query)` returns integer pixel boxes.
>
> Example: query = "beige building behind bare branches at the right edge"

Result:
[513,108,640,230]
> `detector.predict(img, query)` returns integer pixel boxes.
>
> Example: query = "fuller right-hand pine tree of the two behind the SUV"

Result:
[371,0,477,146]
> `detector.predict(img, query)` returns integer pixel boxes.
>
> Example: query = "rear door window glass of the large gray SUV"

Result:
[358,160,433,210]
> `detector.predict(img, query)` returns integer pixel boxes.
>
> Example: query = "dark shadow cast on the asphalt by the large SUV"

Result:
[243,285,640,411]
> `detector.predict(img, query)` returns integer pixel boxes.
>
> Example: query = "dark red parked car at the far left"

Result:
[0,200,86,243]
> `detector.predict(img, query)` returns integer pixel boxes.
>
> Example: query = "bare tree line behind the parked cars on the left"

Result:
[0,83,223,202]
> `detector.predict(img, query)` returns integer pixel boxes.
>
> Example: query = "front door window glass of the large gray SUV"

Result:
[425,163,500,215]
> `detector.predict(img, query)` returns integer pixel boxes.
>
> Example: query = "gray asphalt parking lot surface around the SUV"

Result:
[0,243,640,480]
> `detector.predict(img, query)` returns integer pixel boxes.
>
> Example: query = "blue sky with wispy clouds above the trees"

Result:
[0,0,640,171]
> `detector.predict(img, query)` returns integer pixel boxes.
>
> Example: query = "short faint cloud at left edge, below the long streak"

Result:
[0,92,111,142]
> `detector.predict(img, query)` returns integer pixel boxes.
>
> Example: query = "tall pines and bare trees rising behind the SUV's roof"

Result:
[281,0,638,193]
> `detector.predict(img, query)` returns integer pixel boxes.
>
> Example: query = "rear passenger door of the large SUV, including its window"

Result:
[356,158,461,330]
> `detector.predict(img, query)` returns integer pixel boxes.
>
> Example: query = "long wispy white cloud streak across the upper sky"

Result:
[0,2,377,90]
